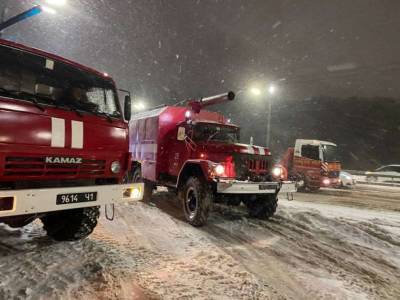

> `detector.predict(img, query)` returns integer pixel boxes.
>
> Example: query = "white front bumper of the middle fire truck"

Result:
[217,180,282,195]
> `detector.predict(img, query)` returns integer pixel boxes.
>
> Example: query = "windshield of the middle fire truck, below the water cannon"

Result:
[193,123,240,143]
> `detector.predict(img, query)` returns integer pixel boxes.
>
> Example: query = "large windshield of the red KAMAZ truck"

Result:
[0,46,121,118]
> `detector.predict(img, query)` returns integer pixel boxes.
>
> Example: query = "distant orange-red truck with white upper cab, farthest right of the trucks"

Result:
[279,139,341,191]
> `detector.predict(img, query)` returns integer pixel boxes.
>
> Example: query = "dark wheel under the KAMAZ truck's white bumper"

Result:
[40,207,100,241]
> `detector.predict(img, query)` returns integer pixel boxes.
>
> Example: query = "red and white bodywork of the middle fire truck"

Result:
[129,106,271,185]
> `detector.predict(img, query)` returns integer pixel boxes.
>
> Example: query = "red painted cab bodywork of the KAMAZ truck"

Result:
[0,40,129,182]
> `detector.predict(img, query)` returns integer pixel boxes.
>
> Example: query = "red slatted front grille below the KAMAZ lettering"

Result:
[3,156,106,177]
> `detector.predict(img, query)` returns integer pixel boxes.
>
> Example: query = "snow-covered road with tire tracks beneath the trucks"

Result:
[0,188,400,299]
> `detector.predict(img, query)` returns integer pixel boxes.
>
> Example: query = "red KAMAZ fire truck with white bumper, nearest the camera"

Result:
[0,40,143,240]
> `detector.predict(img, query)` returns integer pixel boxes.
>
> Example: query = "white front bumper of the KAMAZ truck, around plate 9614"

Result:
[0,183,144,218]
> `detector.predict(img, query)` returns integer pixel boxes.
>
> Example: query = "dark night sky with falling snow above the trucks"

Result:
[0,0,400,105]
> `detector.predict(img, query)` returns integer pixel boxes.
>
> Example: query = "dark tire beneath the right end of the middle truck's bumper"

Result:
[246,195,278,219]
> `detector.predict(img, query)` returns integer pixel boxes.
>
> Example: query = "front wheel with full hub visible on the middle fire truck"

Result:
[180,177,212,227]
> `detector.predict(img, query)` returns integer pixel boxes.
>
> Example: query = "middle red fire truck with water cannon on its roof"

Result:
[129,92,295,226]
